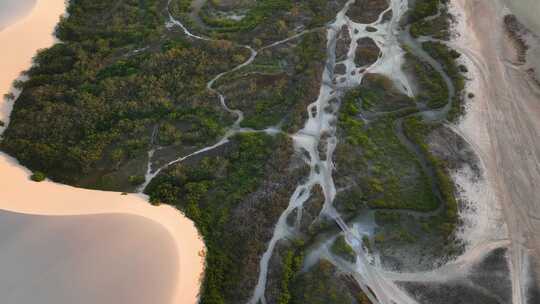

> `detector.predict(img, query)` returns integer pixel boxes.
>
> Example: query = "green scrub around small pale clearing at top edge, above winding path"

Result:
[171,0,344,47]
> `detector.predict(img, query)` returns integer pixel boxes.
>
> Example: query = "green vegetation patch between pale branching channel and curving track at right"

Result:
[336,87,438,211]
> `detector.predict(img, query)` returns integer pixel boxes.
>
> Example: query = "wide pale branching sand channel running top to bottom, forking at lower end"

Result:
[249,0,422,304]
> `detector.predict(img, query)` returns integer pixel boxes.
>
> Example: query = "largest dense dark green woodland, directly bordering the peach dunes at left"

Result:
[2,1,247,190]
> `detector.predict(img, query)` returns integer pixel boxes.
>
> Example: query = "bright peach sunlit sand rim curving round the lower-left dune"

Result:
[0,154,204,304]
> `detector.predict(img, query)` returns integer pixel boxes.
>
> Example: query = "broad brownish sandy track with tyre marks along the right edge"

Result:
[454,0,540,304]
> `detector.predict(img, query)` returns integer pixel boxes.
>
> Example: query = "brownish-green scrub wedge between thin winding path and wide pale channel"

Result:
[218,31,326,129]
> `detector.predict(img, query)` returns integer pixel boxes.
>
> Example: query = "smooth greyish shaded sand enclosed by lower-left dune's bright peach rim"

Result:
[0,211,178,304]
